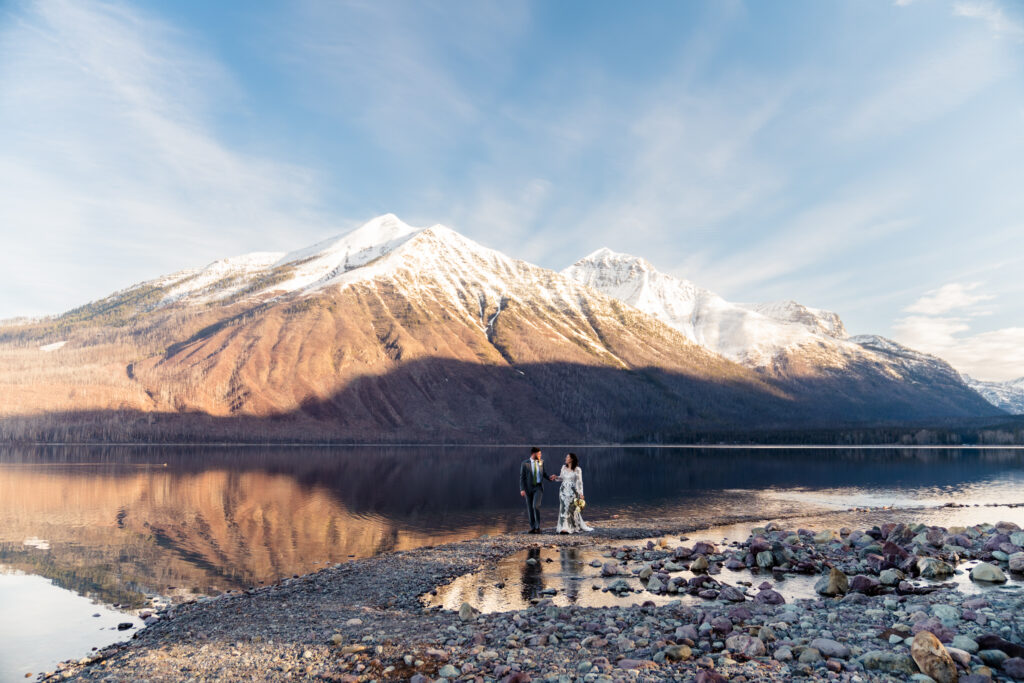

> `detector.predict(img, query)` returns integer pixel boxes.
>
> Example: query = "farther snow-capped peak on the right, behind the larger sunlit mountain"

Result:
[562,249,999,414]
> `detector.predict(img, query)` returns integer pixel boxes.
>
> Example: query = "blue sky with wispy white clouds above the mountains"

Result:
[0,0,1024,380]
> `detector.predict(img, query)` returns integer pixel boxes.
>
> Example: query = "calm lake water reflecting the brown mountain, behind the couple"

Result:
[0,446,1024,680]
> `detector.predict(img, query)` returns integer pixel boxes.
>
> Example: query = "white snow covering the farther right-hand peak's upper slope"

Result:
[562,249,848,367]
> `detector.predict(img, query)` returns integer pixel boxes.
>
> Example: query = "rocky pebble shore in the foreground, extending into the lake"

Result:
[42,521,1024,683]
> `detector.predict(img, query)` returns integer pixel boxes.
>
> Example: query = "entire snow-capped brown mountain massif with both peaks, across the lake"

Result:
[0,215,994,440]
